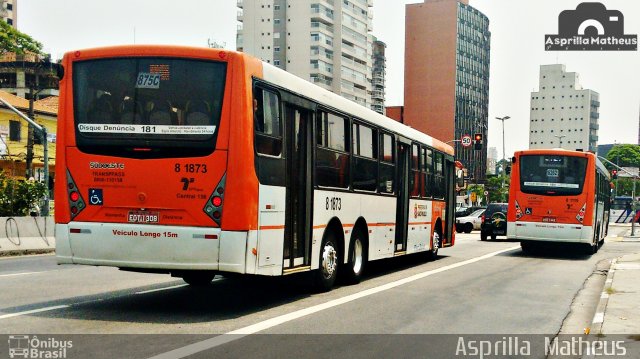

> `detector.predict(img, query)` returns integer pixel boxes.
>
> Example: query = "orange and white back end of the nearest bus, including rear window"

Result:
[55,46,261,277]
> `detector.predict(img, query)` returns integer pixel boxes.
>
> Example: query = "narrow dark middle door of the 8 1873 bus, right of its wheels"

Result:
[394,138,411,252]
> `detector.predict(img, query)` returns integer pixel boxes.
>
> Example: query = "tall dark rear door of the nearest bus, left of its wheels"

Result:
[284,102,314,269]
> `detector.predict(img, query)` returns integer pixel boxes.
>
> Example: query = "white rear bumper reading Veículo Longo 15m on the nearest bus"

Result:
[56,222,251,273]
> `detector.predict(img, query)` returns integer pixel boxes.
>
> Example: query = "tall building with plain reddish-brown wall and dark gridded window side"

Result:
[403,0,491,181]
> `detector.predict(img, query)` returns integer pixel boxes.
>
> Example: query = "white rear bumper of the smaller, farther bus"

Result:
[507,222,593,243]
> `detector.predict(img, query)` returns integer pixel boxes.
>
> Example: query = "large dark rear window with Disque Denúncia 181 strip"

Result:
[73,58,226,157]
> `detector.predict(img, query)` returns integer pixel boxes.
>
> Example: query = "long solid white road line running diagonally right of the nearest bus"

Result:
[149,246,520,359]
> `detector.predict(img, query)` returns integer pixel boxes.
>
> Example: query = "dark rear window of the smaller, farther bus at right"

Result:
[520,155,587,196]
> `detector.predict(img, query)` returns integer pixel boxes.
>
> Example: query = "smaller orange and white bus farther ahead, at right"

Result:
[507,149,611,253]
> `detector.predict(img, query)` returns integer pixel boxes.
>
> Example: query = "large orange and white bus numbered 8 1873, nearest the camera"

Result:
[55,46,455,290]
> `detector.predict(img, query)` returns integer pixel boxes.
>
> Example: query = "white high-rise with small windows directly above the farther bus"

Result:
[529,64,600,152]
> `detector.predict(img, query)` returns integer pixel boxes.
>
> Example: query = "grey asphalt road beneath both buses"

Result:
[0,224,640,358]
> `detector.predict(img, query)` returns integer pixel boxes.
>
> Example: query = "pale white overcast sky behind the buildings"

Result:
[18,0,640,157]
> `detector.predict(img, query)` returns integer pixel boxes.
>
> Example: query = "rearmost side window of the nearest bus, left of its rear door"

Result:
[253,88,282,157]
